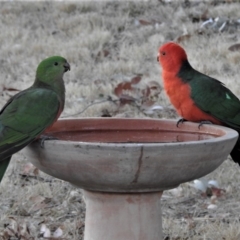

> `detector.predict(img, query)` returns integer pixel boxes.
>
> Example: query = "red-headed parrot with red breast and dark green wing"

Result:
[157,42,240,164]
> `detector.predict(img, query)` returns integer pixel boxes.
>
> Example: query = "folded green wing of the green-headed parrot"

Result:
[0,88,60,161]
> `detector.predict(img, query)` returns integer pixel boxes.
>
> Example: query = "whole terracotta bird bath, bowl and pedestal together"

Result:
[25,118,238,240]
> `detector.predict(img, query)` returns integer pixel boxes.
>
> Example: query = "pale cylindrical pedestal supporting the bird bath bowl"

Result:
[83,190,162,240]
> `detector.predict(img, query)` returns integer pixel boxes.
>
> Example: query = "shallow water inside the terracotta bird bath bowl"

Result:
[49,129,217,143]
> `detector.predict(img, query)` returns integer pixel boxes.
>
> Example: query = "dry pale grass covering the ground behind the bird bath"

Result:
[0,1,240,240]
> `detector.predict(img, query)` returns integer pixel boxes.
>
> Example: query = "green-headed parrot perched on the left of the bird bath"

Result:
[0,56,70,182]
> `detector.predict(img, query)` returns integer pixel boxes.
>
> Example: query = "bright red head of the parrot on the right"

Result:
[158,42,187,73]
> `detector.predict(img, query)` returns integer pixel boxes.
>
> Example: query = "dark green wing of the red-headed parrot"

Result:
[179,65,240,130]
